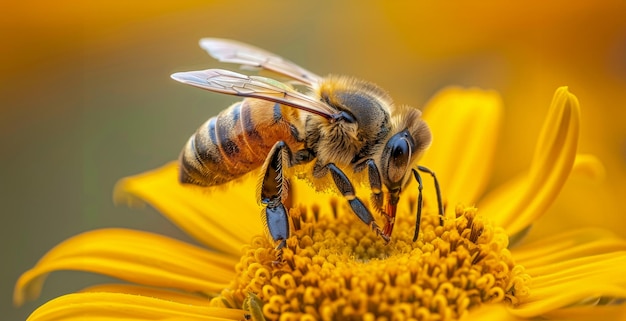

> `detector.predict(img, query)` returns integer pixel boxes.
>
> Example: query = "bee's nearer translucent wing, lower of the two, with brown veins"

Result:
[172,69,338,119]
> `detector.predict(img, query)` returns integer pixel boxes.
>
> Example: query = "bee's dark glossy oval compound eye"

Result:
[386,132,411,188]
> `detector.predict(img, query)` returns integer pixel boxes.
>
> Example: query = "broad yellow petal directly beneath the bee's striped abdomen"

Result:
[114,163,263,255]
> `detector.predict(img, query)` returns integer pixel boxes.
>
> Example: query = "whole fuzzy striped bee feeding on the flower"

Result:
[171,38,443,249]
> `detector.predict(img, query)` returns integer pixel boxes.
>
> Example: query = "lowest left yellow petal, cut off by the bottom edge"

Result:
[27,292,244,321]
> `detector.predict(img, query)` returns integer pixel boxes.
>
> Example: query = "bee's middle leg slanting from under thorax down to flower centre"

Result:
[313,163,389,242]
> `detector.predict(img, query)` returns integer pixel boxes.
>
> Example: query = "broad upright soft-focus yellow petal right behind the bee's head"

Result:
[421,88,502,209]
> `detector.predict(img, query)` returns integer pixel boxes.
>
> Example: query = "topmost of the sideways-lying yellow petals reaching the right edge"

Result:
[511,228,626,268]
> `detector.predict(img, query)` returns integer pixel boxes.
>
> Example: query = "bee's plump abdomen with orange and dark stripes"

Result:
[179,99,302,186]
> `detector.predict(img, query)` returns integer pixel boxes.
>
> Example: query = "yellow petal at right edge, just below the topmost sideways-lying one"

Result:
[512,252,626,318]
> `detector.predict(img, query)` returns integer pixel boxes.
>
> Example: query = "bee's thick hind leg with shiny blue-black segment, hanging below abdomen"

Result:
[259,141,291,263]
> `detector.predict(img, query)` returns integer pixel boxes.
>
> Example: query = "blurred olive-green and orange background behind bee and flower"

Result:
[0,0,626,320]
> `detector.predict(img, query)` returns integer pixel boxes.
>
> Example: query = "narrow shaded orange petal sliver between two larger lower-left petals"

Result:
[80,284,216,306]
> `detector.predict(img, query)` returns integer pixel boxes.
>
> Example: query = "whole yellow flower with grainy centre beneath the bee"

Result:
[14,88,626,320]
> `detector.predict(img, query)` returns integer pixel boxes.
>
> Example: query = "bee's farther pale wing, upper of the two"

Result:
[200,38,321,85]
